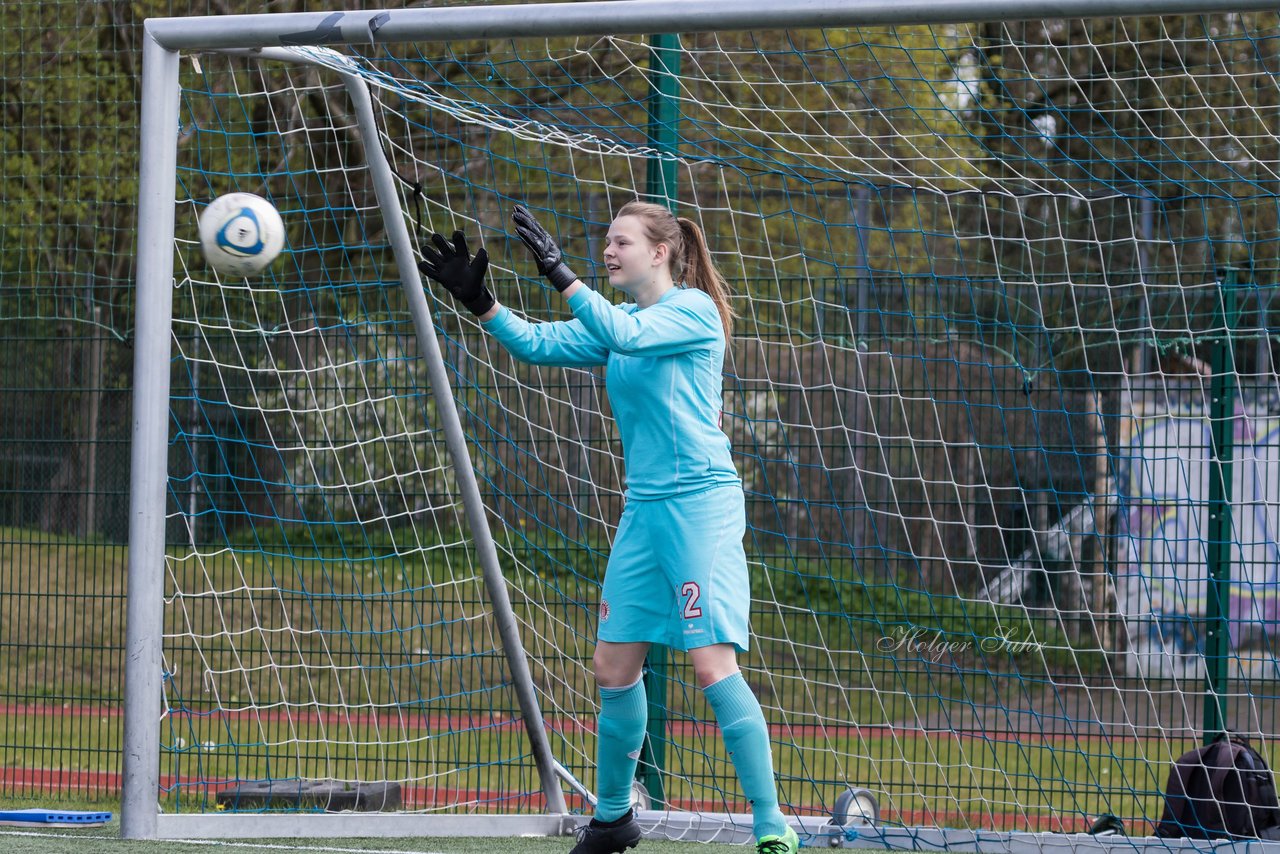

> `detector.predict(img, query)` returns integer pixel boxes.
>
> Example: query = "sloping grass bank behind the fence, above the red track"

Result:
[0,529,1092,723]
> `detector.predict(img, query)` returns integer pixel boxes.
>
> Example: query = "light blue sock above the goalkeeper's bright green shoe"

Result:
[703,673,787,839]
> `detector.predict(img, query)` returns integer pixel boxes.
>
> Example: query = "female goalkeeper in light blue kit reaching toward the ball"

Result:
[420,202,799,854]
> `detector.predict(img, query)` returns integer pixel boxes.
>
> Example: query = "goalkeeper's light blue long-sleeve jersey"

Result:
[484,287,741,501]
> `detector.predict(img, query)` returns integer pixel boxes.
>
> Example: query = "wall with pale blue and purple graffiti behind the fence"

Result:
[1116,411,1280,679]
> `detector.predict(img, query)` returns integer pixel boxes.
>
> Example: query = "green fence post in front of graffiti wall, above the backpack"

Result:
[1204,268,1239,744]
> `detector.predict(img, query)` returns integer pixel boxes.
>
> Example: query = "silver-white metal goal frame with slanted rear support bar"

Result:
[122,0,1280,851]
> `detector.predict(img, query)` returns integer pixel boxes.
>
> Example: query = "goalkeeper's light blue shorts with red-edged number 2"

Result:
[599,484,751,652]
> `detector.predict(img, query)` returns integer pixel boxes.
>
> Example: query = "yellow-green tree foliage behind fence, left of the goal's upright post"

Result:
[0,3,154,323]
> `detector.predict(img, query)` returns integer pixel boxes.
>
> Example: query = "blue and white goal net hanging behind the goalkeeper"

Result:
[129,3,1280,844]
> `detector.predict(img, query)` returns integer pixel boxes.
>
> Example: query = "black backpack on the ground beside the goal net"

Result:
[1156,734,1280,839]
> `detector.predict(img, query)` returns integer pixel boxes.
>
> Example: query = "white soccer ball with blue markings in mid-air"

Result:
[200,193,284,277]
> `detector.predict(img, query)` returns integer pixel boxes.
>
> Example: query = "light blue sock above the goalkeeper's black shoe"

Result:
[595,677,649,822]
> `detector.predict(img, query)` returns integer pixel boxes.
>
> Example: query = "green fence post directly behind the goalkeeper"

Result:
[636,33,680,809]
